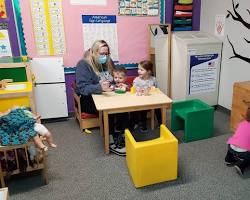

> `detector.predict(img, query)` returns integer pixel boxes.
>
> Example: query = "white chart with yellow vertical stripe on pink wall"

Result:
[30,0,65,55]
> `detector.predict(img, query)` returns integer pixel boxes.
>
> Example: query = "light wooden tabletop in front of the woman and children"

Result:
[92,90,172,111]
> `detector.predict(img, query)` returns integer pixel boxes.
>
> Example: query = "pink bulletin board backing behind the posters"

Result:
[20,0,160,67]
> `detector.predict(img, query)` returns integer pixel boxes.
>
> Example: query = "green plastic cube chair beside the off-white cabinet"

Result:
[171,99,214,142]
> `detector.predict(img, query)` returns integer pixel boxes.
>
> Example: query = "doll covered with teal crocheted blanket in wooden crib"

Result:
[0,107,56,151]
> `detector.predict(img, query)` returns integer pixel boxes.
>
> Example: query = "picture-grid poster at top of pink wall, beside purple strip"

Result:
[119,0,159,16]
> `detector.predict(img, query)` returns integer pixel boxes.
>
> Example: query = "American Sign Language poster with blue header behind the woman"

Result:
[82,15,119,61]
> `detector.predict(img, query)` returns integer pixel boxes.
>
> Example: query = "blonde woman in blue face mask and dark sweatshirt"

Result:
[75,40,124,155]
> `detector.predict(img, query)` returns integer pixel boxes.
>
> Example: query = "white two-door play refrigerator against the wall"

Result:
[31,57,68,119]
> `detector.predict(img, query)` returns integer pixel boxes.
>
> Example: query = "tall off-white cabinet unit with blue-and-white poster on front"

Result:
[171,31,222,106]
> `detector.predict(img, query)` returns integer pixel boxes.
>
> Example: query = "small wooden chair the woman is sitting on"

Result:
[71,83,100,130]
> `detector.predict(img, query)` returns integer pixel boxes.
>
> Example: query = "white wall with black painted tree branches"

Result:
[200,0,250,109]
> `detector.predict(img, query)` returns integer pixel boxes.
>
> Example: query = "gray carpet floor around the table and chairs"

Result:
[8,109,250,200]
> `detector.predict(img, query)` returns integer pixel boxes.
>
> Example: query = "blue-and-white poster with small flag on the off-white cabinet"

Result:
[189,54,219,95]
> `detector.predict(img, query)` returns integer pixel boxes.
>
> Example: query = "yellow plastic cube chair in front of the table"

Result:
[125,125,178,188]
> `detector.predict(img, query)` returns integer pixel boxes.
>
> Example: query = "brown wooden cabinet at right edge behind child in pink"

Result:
[230,81,250,131]
